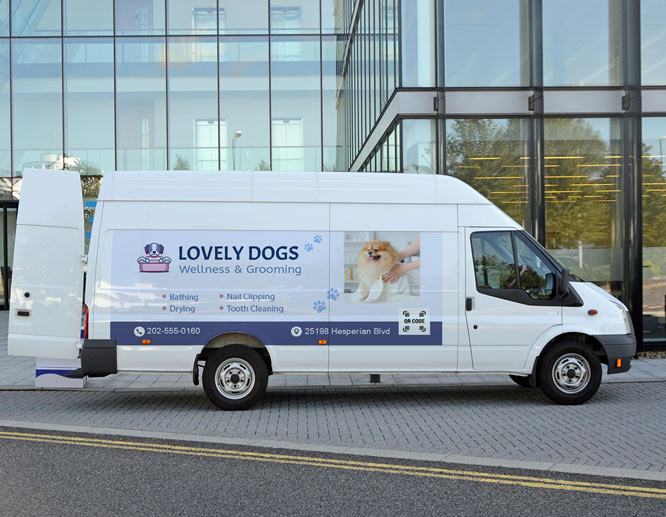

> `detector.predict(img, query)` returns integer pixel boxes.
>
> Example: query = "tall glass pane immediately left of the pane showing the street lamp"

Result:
[169,36,219,170]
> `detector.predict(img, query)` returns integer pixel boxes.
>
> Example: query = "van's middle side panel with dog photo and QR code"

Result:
[329,204,458,373]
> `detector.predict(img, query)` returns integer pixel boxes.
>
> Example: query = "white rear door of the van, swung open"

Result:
[8,169,83,359]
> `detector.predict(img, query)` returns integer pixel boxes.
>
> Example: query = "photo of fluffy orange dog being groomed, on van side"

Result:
[345,232,420,303]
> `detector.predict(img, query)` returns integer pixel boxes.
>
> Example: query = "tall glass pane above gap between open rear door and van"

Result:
[64,38,115,175]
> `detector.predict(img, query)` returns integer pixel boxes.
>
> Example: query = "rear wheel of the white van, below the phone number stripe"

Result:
[203,345,268,411]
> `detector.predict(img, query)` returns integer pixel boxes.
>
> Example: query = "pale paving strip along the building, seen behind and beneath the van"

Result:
[0,311,666,390]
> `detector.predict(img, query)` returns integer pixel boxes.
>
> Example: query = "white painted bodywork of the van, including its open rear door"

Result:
[9,171,628,382]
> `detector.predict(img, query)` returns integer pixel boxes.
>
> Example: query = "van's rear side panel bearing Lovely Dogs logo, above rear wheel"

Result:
[93,201,329,372]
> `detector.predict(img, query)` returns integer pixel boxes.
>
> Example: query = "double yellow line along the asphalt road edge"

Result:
[0,431,666,499]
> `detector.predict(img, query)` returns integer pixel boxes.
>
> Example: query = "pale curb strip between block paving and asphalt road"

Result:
[0,420,666,481]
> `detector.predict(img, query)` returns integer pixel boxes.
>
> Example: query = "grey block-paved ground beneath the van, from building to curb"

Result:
[0,310,666,481]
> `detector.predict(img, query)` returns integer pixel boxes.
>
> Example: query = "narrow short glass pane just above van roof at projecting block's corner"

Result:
[402,119,437,174]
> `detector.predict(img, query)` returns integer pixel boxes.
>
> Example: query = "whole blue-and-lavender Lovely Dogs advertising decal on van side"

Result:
[107,230,443,345]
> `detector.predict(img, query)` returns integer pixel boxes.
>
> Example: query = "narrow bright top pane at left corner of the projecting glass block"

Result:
[400,0,437,86]
